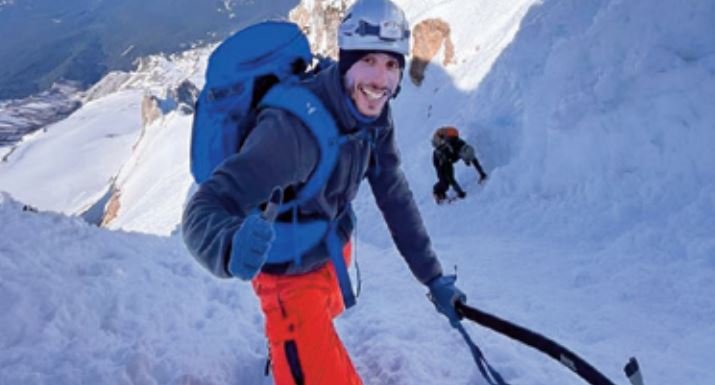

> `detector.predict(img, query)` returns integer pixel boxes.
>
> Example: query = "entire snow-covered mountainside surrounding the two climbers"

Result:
[0,0,715,385]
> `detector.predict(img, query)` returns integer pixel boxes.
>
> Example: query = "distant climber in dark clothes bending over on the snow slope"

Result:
[432,127,487,203]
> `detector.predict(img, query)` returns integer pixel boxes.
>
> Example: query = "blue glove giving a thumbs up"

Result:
[228,213,276,281]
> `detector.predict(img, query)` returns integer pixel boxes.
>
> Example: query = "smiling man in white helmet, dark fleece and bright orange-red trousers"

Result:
[182,0,465,385]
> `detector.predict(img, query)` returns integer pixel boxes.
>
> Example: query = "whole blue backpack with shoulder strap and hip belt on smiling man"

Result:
[190,21,355,307]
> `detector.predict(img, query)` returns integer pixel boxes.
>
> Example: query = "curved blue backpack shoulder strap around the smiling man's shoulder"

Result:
[259,84,340,212]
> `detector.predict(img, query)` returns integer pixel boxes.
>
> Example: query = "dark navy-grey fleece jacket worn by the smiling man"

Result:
[182,65,442,283]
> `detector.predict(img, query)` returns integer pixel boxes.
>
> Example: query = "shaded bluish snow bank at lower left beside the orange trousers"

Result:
[0,194,265,385]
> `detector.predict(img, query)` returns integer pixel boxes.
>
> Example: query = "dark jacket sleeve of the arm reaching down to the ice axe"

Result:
[368,121,442,284]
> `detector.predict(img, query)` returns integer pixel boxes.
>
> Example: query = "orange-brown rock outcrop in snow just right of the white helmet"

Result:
[410,19,454,86]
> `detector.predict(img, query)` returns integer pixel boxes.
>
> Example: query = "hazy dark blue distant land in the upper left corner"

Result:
[0,0,298,100]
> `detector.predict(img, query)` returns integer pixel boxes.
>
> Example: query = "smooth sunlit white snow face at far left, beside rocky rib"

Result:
[0,90,142,214]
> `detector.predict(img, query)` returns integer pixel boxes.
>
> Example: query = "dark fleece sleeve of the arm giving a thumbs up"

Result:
[181,109,319,278]
